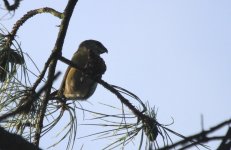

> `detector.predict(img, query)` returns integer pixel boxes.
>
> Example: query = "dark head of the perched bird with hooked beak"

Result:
[79,40,108,55]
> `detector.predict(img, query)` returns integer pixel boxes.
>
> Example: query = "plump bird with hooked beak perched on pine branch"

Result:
[53,40,108,100]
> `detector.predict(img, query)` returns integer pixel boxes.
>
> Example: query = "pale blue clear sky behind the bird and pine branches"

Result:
[0,0,231,149]
